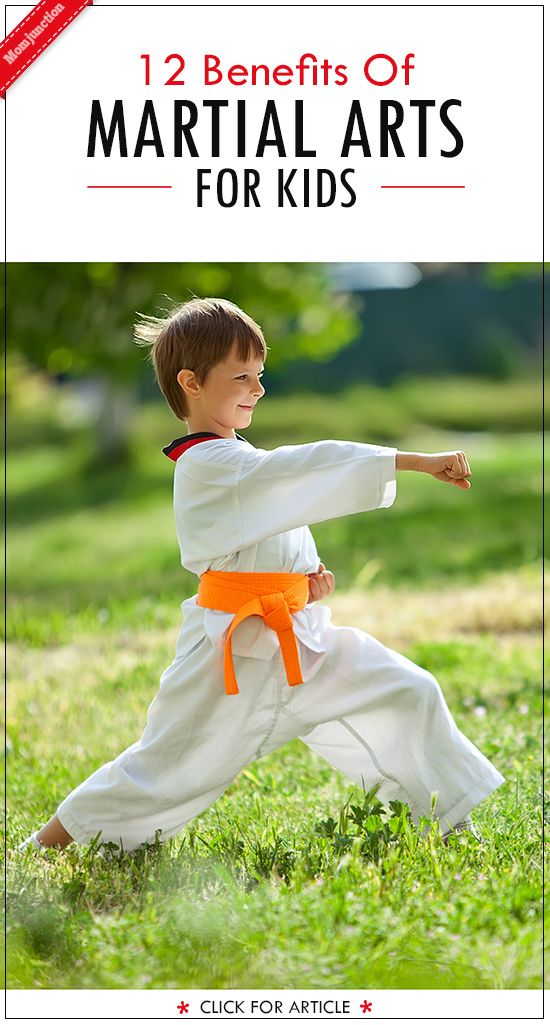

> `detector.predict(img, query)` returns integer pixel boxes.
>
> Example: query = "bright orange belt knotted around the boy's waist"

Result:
[197,570,309,694]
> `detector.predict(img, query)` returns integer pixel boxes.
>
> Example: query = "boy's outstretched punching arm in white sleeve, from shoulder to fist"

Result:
[174,440,469,566]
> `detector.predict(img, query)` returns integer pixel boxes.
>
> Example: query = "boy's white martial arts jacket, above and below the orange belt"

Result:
[170,436,396,680]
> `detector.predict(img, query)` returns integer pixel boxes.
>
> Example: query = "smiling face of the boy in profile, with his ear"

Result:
[178,346,265,437]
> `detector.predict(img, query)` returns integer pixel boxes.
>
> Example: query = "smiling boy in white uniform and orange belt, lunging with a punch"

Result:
[22,299,504,851]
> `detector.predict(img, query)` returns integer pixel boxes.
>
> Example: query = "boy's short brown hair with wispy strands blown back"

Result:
[134,298,267,420]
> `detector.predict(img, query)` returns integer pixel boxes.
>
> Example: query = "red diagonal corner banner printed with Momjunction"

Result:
[0,0,93,99]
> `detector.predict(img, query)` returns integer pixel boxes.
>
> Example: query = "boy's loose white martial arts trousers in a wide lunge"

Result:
[57,624,504,851]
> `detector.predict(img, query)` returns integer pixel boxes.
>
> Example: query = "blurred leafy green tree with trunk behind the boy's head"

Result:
[7,263,359,461]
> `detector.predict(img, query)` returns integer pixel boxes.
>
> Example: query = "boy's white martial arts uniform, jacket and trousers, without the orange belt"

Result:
[57,436,504,850]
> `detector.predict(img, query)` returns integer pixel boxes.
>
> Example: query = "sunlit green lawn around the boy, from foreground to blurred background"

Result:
[7,385,542,989]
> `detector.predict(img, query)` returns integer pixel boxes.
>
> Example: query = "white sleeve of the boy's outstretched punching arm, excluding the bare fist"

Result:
[238,441,396,547]
